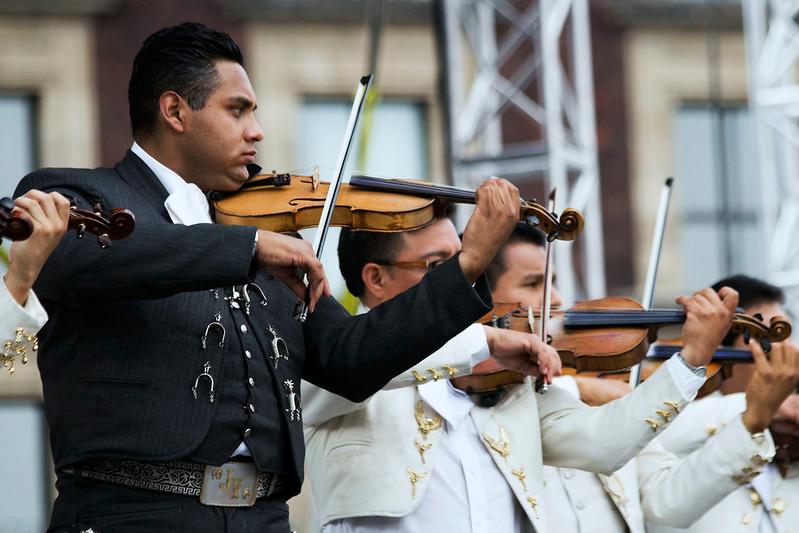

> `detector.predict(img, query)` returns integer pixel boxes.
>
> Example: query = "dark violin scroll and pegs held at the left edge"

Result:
[0,198,136,248]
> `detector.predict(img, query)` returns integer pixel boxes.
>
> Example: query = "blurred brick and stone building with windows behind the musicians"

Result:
[0,0,788,532]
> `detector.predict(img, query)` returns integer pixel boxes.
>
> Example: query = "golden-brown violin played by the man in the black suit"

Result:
[212,169,583,241]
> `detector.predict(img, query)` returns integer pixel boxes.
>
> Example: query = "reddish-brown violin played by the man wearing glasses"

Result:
[452,296,791,393]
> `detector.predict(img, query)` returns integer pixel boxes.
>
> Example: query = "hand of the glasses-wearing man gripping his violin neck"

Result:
[676,287,738,366]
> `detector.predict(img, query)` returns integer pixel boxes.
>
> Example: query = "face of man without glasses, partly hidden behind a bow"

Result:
[491,242,563,308]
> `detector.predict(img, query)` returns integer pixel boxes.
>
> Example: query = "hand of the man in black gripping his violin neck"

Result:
[458,178,520,283]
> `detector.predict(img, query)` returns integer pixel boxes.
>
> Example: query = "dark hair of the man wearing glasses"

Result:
[338,203,455,298]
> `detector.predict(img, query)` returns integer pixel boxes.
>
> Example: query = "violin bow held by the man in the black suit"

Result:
[294,74,372,322]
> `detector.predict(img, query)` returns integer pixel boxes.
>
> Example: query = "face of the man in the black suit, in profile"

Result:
[180,61,264,191]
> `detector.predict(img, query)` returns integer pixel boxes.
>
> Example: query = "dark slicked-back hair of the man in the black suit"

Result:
[128,22,243,139]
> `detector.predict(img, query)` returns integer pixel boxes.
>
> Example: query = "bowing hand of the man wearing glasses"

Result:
[484,326,560,383]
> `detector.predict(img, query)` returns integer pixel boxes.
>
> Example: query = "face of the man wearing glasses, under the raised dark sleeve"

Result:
[375,218,461,305]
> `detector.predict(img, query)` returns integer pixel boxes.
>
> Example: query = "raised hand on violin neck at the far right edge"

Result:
[743,341,799,433]
